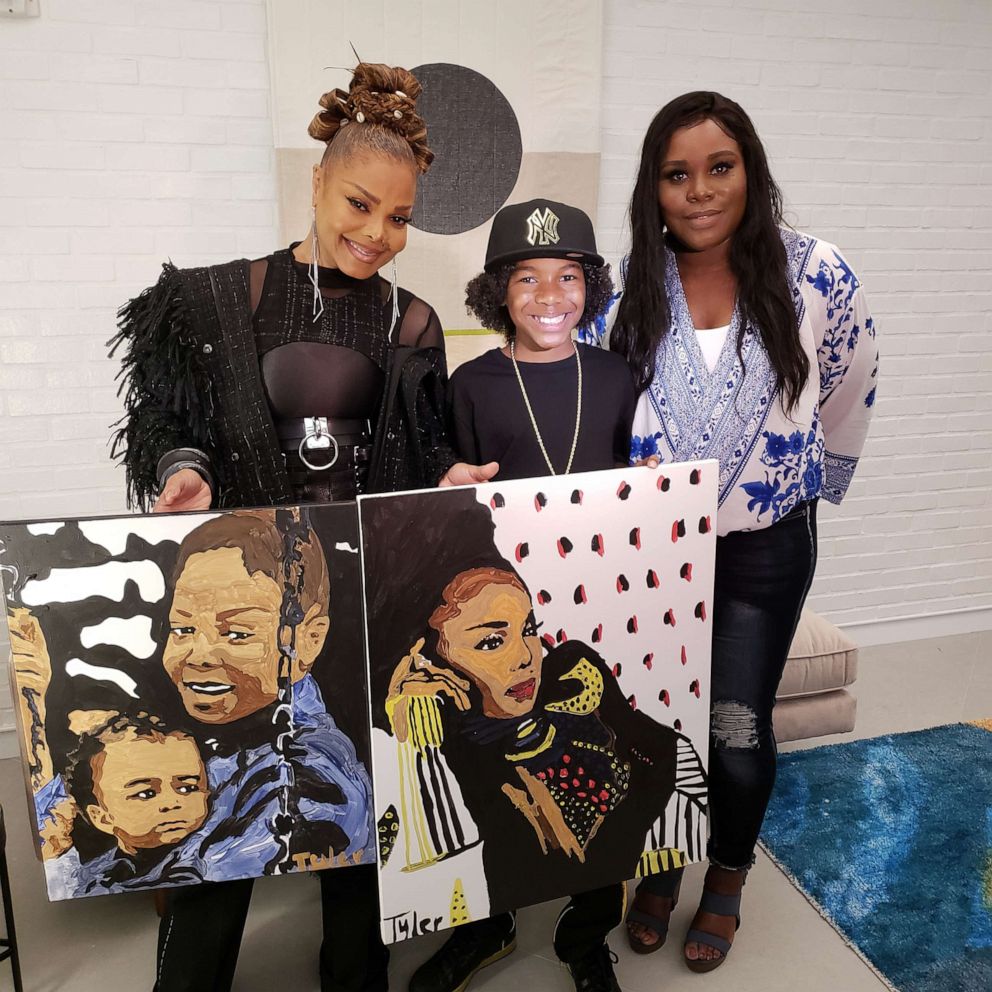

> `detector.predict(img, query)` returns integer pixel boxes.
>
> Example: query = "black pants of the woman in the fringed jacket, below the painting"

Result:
[154,865,389,992]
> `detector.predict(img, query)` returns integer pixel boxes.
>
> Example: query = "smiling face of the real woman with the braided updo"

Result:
[313,154,417,279]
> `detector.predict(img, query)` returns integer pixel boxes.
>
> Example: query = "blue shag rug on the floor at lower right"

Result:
[762,721,992,992]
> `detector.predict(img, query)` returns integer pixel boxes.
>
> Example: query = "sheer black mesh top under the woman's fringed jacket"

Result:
[251,245,444,419]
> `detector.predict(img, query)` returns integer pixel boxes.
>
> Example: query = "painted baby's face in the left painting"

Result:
[86,728,208,854]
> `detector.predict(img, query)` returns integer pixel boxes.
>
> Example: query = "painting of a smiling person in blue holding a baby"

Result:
[0,504,376,899]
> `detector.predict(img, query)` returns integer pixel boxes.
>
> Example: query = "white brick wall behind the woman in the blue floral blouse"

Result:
[598,0,992,637]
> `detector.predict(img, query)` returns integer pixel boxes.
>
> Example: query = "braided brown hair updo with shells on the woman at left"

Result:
[307,62,434,173]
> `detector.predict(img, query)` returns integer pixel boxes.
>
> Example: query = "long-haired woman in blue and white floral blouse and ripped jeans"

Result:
[610,92,878,971]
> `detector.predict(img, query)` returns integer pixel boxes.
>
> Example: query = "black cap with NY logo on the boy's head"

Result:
[485,200,603,272]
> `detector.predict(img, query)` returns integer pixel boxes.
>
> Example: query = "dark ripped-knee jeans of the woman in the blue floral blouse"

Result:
[641,500,816,895]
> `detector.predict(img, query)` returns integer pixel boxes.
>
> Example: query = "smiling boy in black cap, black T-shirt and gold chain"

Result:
[409,199,636,992]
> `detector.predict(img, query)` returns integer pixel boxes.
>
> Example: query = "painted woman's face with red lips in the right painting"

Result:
[442,583,543,718]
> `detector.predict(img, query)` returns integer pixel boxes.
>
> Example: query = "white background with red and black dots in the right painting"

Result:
[480,463,717,752]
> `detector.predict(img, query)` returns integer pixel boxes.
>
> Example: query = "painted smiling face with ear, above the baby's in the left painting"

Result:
[162,548,328,723]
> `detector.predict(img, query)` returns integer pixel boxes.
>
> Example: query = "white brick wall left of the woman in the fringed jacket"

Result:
[0,0,277,752]
